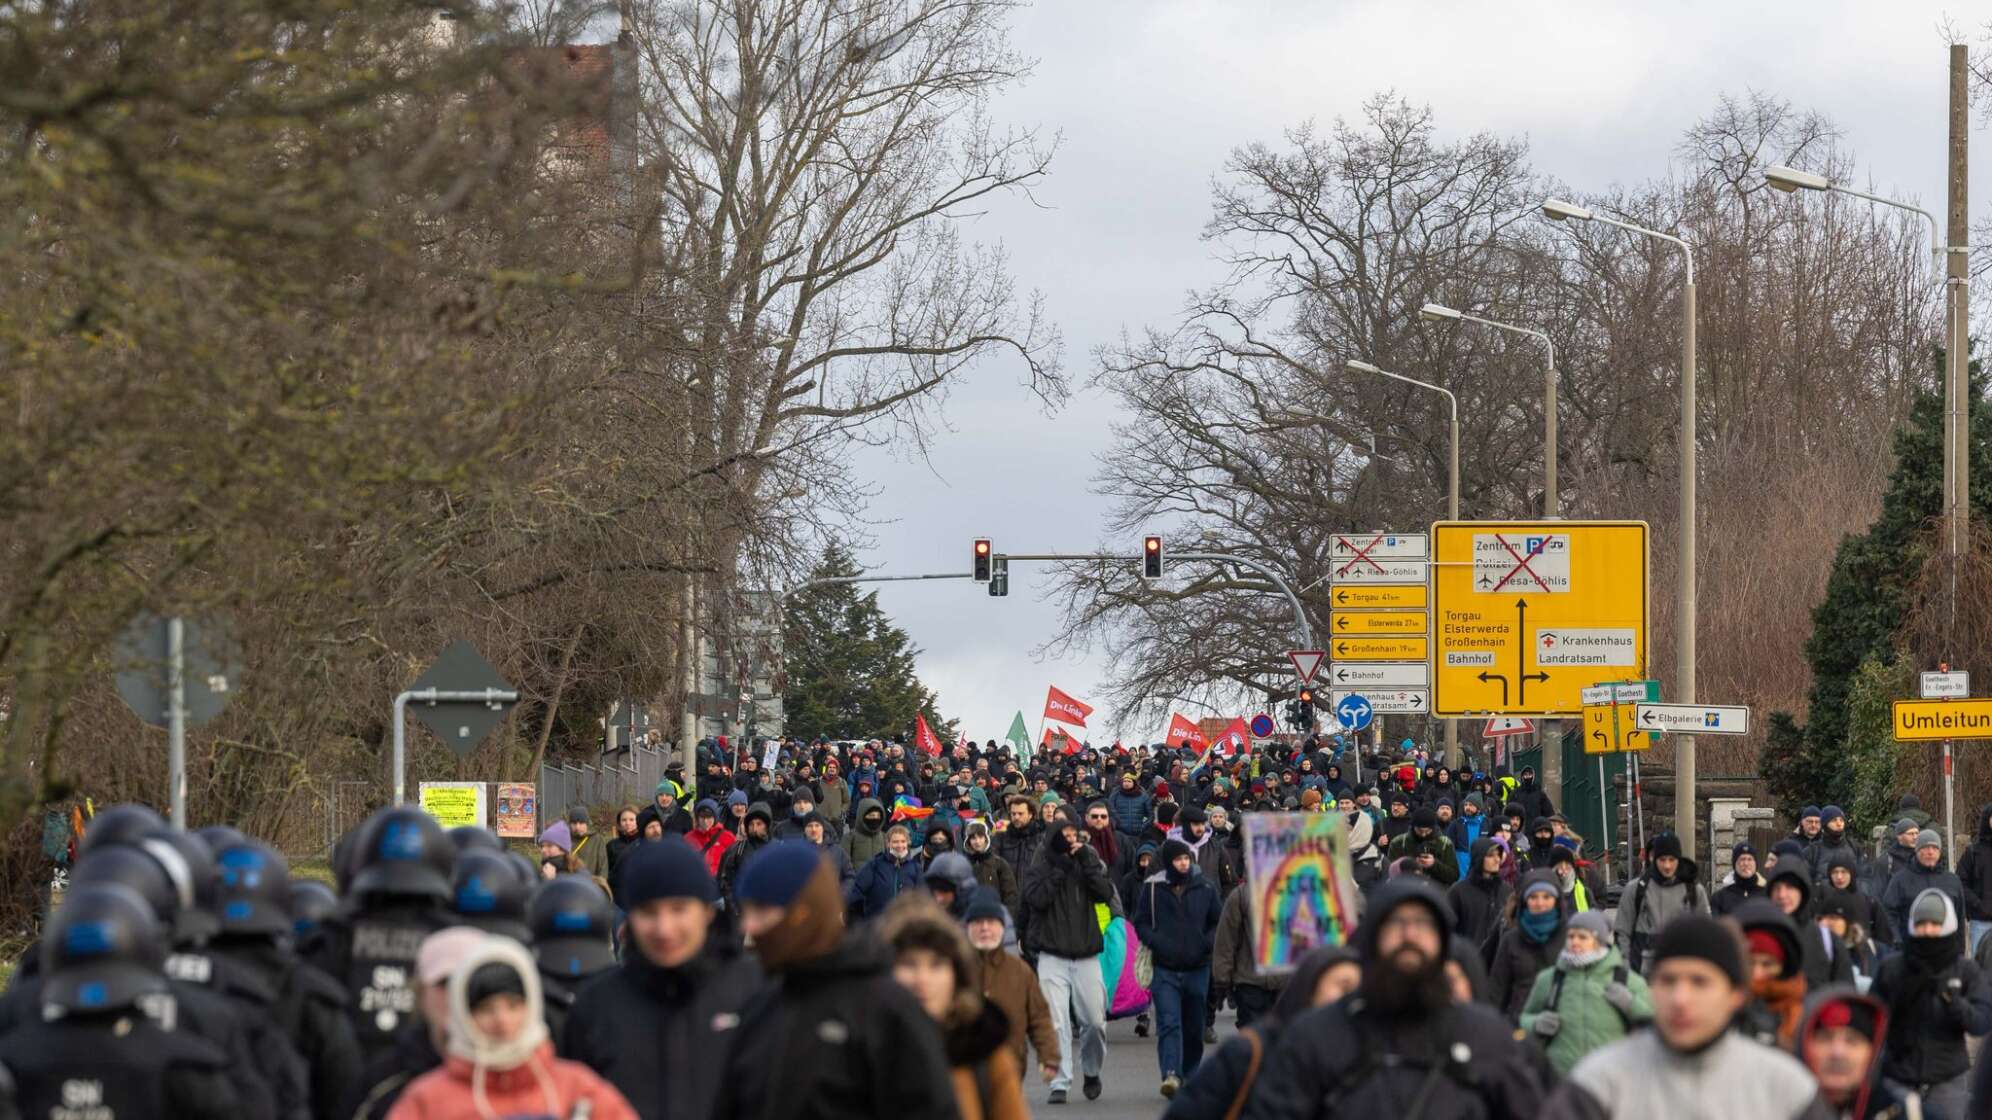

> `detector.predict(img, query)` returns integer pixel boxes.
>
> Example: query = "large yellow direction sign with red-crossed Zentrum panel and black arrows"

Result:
[1432,520,1647,715]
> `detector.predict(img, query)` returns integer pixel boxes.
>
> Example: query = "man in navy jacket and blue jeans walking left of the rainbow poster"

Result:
[1133,839,1223,1096]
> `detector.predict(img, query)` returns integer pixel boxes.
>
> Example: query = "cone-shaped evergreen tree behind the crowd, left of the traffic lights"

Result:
[781,542,956,749]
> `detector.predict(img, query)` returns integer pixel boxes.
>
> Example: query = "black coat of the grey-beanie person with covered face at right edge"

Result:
[1868,931,1992,1086]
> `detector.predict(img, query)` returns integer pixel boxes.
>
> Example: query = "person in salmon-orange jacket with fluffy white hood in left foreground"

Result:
[386,935,637,1120]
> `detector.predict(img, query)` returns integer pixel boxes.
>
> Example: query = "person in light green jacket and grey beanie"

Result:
[1522,911,1653,1076]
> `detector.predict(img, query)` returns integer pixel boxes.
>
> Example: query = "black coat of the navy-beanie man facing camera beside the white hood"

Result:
[560,937,763,1120]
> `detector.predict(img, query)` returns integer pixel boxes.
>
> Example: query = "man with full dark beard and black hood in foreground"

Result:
[1245,875,1542,1120]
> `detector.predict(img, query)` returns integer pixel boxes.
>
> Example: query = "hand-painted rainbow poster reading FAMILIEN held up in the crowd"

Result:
[1245,813,1357,973]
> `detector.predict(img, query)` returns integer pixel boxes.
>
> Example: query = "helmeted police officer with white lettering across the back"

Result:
[309,805,456,1058]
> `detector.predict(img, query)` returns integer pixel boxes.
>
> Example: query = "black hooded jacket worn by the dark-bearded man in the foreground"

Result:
[1245,875,1544,1120]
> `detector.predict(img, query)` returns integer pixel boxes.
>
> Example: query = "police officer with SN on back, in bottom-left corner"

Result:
[0,883,241,1120]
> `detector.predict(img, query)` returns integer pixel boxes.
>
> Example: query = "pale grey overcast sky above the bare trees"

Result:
[859,0,1992,741]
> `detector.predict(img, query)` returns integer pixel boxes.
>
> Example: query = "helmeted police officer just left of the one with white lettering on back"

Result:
[209,841,361,1120]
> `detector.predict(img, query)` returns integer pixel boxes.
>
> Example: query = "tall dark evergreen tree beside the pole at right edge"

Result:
[1761,355,1992,823]
